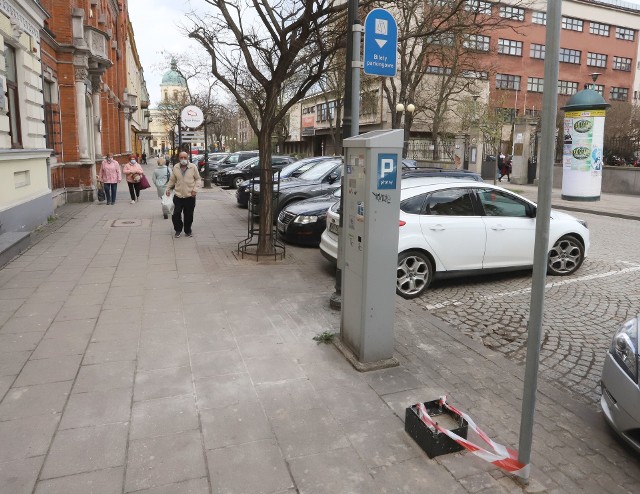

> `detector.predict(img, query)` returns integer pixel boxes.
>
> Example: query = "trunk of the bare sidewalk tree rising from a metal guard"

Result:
[257,129,275,256]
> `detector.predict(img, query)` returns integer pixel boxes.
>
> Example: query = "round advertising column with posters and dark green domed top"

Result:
[562,89,609,201]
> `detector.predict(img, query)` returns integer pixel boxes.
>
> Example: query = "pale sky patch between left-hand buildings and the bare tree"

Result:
[129,0,206,108]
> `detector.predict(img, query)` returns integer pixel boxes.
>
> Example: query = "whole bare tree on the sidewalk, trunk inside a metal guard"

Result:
[189,0,347,255]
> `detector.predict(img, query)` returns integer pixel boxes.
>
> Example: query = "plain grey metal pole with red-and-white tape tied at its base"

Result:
[518,0,562,484]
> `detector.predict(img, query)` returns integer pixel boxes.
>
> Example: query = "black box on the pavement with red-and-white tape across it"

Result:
[404,400,469,458]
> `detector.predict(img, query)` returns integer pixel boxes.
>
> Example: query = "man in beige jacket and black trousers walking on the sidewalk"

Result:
[165,151,200,238]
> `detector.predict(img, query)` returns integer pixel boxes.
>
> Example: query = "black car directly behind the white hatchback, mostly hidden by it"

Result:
[277,166,483,245]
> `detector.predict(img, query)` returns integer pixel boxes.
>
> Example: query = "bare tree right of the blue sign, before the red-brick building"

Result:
[382,0,522,153]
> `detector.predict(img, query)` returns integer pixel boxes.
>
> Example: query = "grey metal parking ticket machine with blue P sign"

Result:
[340,129,403,363]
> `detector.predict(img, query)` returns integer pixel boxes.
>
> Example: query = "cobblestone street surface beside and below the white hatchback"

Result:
[409,213,640,405]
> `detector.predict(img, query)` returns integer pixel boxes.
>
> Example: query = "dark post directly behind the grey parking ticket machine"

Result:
[329,0,360,309]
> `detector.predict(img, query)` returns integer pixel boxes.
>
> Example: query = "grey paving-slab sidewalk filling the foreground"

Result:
[0,166,640,493]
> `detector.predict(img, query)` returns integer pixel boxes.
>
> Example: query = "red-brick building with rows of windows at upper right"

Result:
[468,0,640,115]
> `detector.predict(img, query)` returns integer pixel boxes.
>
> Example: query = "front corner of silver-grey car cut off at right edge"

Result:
[600,315,640,453]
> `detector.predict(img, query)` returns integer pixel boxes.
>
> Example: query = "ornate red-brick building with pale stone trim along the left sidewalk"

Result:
[40,0,148,205]
